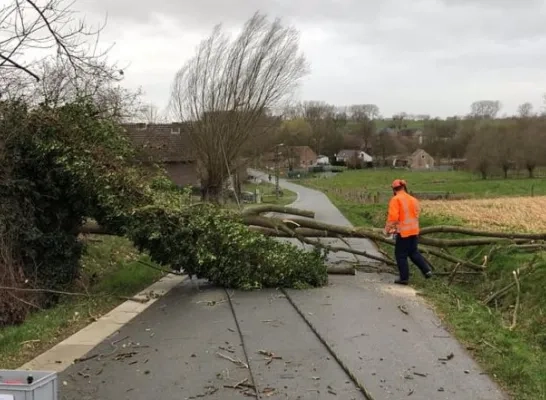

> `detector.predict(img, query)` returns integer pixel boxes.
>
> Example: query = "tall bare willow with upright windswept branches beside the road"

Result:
[170,13,308,201]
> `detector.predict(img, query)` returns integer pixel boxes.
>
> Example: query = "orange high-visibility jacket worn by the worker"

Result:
[385,190,420,238]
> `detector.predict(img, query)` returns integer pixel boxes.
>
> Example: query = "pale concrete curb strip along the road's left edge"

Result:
[19,274,187,372]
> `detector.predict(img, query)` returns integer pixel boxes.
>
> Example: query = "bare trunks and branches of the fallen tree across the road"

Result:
[81,205,546,275]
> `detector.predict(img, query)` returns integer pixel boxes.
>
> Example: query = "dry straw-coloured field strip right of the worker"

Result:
[421,196,546,232]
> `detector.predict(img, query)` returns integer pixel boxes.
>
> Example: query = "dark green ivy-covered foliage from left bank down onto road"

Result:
[0,97,327,328]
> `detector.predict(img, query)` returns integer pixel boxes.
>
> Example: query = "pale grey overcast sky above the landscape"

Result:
[76,0,546,117]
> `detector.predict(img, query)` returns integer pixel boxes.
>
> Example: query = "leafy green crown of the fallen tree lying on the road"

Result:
[129,205,327,289]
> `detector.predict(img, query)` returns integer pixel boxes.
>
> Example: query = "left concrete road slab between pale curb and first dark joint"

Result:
[59,280,254,400]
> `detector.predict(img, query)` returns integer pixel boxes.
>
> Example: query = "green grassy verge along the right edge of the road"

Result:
[308,189,546,400]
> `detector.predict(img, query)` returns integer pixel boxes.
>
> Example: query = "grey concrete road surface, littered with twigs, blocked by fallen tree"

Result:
[60,173,505,400]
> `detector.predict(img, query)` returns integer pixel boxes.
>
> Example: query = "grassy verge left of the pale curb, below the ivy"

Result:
[0,236,163,369]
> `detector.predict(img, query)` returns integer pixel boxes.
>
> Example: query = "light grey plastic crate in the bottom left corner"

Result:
[0,370,58,400]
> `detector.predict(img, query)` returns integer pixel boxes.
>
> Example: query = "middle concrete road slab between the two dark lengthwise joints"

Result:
[232,290,365,400]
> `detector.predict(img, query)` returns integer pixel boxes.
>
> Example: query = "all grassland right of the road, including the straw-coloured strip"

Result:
[304,170,546,400]
